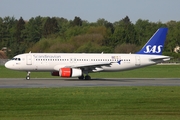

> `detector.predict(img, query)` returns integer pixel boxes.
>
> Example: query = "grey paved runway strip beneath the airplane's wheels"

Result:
[0,78,180,88]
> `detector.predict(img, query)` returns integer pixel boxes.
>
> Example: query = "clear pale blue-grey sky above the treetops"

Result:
[0,0,180,23]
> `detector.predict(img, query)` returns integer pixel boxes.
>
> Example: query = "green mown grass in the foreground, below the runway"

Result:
[0,86,180,120]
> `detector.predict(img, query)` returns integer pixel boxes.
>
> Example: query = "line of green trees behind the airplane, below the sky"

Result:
[0,16,180,58]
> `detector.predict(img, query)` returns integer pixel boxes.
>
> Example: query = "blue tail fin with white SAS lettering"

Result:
[137,28,168,55]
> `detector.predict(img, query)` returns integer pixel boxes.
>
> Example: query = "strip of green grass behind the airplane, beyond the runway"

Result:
[0,65,180,78]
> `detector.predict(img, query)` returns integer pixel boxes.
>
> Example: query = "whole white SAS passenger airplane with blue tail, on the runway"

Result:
[5,28,171,80]
